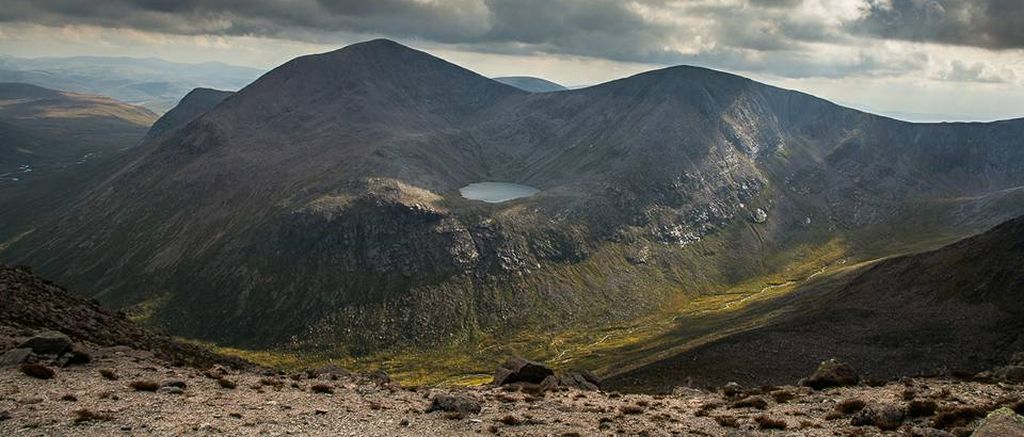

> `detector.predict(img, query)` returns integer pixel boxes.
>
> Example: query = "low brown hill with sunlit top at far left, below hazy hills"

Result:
[0,83,157,175]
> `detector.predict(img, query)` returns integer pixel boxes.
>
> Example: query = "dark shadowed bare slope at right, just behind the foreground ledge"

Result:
[607,217,1024,391]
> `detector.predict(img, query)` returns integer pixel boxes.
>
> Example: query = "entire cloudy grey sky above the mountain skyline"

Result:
[0,0,1024,121]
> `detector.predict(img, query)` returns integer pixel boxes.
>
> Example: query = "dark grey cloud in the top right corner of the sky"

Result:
[851,0,1024,49]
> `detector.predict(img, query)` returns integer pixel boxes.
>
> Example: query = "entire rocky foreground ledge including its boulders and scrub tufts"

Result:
[0,333,1024,437]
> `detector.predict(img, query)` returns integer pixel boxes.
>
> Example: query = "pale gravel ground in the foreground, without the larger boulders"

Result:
[0,347,1021,436]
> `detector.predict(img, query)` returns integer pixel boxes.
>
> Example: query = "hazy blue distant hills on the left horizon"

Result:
[0,56,264,113]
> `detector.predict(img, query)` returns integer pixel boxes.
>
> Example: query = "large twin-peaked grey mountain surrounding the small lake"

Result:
[0,40,1024,370]
